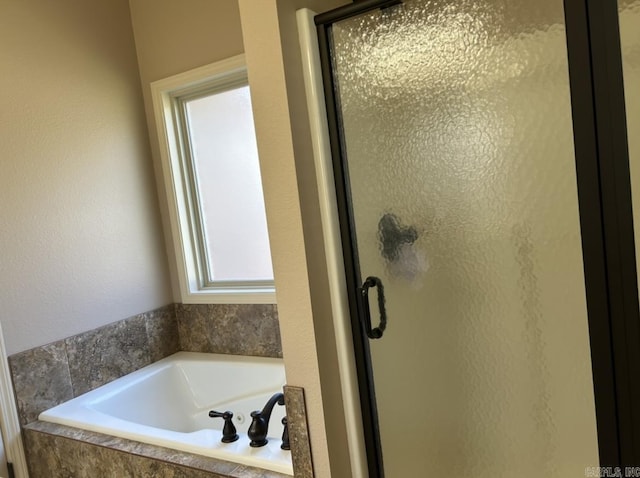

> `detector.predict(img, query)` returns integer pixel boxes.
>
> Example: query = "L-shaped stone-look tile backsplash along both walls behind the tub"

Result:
[9,304,282,425]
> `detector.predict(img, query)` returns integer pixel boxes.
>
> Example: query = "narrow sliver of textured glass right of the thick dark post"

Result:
[618,0,640,292]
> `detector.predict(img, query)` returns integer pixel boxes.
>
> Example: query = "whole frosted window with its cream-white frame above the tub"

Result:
[151,55,275,303]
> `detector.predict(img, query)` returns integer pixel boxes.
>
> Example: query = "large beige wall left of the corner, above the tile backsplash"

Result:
[0,0,172,354]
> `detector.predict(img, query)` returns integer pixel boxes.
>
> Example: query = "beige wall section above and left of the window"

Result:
[129,0,243,302]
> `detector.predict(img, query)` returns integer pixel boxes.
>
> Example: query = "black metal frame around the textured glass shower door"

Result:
[315,0,640,478]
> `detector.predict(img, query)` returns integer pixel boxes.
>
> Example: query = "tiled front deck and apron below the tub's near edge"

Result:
[24,422,290,478]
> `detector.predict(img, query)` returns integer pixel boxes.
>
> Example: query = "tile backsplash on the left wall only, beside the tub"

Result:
[9,304,179,425]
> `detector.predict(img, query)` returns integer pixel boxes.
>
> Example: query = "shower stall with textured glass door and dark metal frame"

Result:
[304,0,640,478]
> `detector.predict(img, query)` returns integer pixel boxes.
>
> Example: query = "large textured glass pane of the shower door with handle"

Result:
[332,0,598,478]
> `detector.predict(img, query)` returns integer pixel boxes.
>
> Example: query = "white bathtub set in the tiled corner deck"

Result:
[39,352,293,475]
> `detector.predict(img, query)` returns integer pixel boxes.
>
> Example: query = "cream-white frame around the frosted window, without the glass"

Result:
[151,55,276,304]
